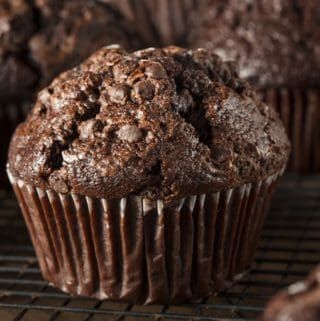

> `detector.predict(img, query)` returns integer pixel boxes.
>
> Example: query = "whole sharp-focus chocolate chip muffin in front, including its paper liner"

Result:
[8,47,290,304]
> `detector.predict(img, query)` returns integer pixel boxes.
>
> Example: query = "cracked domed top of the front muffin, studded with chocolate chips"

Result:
[8,46,290,202]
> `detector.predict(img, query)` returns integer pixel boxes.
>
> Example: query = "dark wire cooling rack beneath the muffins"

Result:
[0,176,320,321]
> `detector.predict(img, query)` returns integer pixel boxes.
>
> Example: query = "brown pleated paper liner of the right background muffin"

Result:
[262,88,320,173]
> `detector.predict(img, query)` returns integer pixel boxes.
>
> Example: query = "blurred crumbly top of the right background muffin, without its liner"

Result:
[189,0,320,87]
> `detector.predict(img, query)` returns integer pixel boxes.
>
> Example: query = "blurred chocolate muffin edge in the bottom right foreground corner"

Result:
[260,267,320,321]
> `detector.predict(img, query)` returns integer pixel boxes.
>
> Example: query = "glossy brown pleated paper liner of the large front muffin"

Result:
[9,169,282,304]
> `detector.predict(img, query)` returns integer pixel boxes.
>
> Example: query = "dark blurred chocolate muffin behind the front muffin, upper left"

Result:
[0,0,138,186]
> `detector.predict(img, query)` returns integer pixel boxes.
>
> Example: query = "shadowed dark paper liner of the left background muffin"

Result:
[0,104,29,189]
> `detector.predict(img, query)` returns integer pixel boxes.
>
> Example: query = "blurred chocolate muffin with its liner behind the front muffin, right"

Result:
[189,0,320,172]
